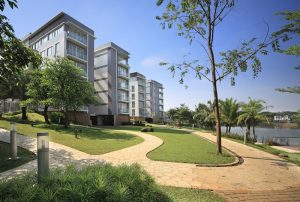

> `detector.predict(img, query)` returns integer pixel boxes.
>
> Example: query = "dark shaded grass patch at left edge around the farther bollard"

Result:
[0,142,36,172]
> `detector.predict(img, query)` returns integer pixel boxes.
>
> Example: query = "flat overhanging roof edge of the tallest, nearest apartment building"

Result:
[23,11,94,41]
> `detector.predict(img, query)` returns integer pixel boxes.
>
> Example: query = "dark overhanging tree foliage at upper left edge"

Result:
[0,0,41,83]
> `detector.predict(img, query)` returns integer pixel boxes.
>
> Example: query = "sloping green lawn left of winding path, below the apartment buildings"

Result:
[0,119,143,155]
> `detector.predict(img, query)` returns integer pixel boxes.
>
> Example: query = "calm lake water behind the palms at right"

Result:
[221,126,300,146]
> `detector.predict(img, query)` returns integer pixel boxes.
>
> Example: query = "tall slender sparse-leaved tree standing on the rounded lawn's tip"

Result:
[156,0,271,154]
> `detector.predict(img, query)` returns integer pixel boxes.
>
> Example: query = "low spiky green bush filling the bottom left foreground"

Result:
[0,164,170,201]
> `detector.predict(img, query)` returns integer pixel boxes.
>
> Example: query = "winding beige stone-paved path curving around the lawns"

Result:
[0,128,300,201]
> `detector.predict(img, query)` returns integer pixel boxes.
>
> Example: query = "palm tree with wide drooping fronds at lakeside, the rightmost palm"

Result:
[237,98,268,141]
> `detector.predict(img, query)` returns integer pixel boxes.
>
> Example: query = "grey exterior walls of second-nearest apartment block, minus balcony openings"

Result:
[92,43,129,125]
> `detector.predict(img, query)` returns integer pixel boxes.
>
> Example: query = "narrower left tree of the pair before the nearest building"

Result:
[26,69,52,124]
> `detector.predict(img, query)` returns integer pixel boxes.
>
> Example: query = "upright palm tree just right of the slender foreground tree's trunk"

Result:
[220,98,240,133]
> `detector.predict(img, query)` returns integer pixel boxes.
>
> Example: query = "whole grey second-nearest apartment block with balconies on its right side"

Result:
[92,42,129,125]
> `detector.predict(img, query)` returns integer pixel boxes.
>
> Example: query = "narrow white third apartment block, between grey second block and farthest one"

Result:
[129,72,146,121]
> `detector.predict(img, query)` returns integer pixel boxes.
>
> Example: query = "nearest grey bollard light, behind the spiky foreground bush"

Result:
[37,132,49,182]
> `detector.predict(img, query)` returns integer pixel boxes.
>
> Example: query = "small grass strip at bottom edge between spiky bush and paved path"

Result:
[160,186,225,202]
